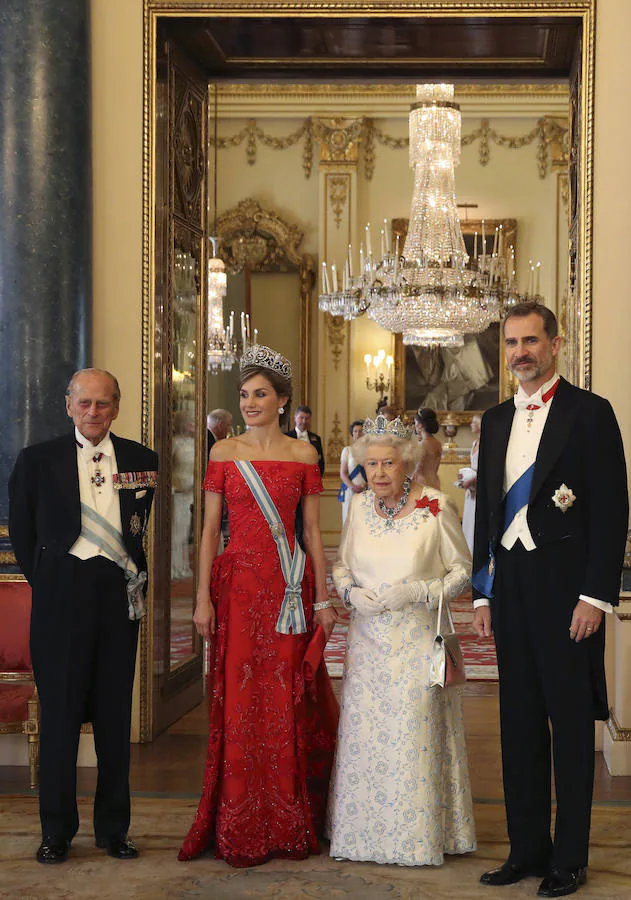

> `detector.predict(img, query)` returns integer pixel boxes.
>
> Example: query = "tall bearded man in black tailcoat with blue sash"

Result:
[472,303,629,897]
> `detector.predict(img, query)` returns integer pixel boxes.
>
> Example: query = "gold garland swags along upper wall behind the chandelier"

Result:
[210,116,568,181]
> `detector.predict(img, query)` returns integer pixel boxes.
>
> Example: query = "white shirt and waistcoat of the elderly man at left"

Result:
[68,427,138,572]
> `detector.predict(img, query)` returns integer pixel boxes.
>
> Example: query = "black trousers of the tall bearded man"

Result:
[492,542,604,868]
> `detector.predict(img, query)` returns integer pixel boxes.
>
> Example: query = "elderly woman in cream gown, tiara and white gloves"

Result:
[327,416,476,866]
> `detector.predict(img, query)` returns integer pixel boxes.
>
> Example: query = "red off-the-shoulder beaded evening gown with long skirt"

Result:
[179,460,337,866]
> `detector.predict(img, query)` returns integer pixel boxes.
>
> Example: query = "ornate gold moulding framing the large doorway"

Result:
[139,0,596,740]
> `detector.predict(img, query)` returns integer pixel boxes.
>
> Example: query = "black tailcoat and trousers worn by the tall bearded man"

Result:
[473,378,629,868]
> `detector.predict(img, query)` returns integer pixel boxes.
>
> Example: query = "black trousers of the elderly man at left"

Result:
[31,553,138,840]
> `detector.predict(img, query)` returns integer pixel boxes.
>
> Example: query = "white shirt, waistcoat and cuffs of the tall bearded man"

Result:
[473,372,612,612]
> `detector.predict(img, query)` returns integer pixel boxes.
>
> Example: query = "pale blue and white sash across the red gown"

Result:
[235,460,307,634]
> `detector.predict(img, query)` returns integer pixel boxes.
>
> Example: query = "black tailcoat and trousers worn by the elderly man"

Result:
[9,432,158,840]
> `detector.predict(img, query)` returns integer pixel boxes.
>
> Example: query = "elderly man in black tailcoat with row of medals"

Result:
[9,369,158,864]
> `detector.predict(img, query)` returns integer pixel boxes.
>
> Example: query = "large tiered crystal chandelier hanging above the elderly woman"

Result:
[319,84,541,347]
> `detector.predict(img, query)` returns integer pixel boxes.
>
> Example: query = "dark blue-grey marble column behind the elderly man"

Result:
[0,0,92,571]
